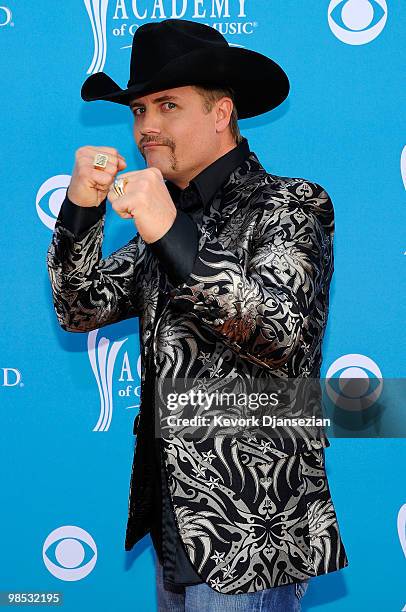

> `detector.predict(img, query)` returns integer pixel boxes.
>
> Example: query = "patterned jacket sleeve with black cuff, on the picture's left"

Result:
[47,196,145,332]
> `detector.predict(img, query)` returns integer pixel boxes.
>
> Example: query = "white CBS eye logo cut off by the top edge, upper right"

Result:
[327,0,388,45]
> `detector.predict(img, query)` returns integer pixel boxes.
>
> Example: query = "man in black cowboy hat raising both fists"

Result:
[47,19,348,612]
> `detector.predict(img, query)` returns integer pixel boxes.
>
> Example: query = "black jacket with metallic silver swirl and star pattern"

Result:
[47,142,348,594]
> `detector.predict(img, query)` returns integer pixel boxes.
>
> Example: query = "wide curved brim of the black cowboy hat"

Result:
[81,46,290,119]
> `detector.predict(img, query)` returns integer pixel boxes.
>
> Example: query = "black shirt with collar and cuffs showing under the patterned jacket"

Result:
[55,137,250,592]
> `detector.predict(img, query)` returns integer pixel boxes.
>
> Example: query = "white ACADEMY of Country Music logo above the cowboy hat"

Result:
[83,0,258,74]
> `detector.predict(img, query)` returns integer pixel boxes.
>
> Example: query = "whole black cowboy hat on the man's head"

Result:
[81,19,289,119]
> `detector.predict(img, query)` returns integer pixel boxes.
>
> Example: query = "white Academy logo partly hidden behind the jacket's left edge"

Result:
[87,329,141,431]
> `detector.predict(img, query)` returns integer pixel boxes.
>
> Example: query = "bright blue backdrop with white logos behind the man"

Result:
[0,0,406,612]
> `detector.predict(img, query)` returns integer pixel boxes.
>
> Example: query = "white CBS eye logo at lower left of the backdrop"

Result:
[42,525,97,581]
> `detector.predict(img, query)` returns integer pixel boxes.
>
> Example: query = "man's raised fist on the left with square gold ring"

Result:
[67,146,127,207]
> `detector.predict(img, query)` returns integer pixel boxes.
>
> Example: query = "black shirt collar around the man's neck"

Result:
[165,136,250,207]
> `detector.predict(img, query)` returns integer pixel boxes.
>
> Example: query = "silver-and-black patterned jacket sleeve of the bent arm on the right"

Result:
[163,181,334,369]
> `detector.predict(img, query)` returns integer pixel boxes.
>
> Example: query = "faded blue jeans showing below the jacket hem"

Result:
[156,559,310,612]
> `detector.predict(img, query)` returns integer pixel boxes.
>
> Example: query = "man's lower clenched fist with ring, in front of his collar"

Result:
[108,167,176,243]
